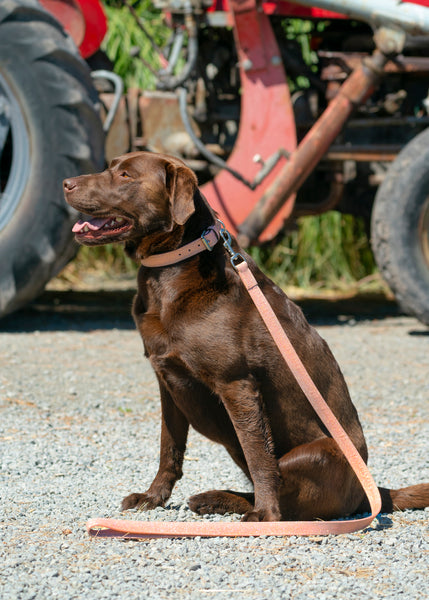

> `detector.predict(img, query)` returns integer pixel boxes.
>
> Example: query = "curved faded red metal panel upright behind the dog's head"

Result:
[203,0,296,240]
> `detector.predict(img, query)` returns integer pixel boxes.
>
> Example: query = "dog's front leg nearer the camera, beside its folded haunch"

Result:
[219,376,281,521]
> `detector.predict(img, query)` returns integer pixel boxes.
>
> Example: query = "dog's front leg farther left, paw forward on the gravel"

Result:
[122,381,189,510]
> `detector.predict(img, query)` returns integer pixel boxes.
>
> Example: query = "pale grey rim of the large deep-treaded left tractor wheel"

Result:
[0,74,30,231]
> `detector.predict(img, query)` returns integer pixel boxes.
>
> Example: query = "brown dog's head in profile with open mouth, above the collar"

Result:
[63,152,197,246]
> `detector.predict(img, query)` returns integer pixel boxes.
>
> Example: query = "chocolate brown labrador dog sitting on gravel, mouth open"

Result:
[64,152,429,521]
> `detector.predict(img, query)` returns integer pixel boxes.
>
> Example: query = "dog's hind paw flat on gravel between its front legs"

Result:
[188,490,255,515]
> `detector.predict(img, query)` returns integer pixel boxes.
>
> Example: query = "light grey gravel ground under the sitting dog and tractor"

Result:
[0,293,429,600]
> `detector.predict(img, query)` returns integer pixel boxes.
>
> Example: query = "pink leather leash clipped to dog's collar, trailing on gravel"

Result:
[86,221,381,539]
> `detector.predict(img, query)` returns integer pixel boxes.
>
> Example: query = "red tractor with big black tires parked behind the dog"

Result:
[0,0,429,324]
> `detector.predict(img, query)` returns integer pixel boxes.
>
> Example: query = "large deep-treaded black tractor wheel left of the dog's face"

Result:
[0,0,104,316]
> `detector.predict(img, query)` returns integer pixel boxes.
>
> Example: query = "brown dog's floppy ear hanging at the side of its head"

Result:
[166,163,198,225]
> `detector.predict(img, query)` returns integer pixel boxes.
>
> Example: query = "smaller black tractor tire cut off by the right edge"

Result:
[371,124,429,325]
